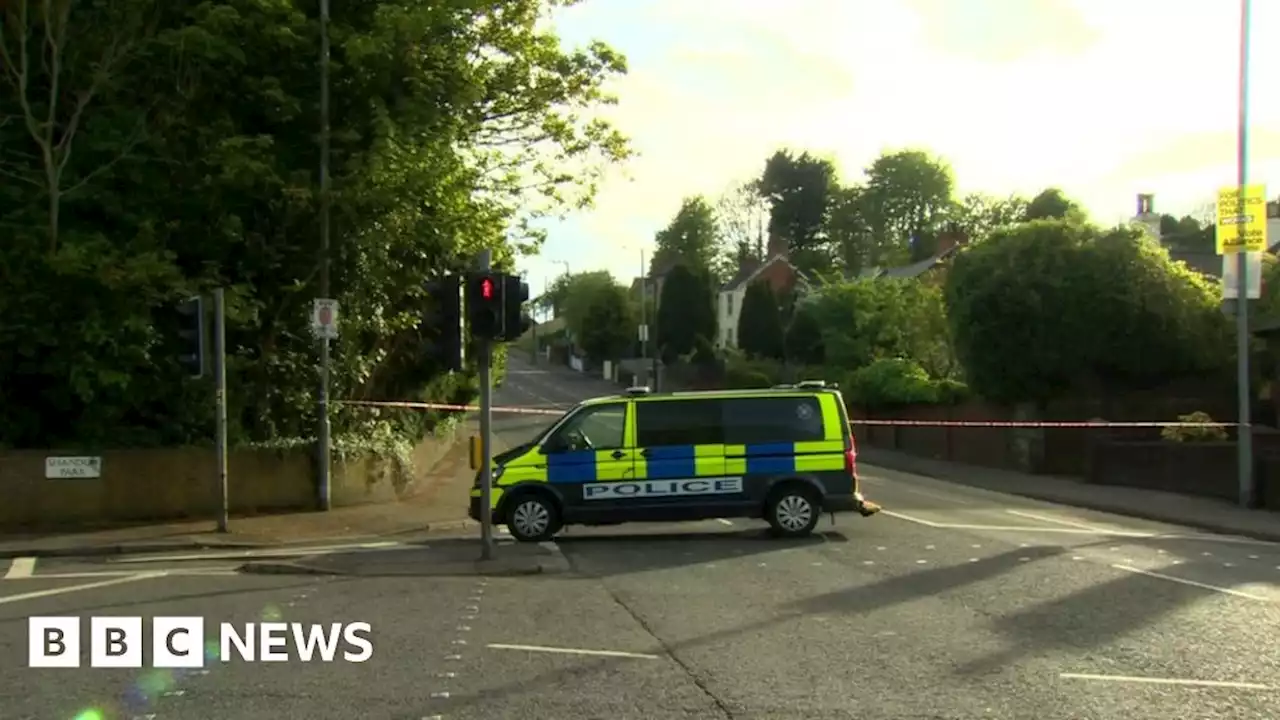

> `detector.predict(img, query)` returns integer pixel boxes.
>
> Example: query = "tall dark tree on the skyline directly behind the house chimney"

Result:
[759,150,836,263]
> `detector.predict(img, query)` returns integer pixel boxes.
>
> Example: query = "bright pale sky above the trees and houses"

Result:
[520,0,1280,296]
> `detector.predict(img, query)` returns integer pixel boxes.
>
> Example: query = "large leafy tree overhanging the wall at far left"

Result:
[0,0,630,446]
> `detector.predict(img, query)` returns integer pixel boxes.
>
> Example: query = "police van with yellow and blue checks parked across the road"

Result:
[470,380,879,542]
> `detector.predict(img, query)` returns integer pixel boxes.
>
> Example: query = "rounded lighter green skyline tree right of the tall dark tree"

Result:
[864,150,955,264]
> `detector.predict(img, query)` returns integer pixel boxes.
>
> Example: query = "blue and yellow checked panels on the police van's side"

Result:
[471,393,845,507]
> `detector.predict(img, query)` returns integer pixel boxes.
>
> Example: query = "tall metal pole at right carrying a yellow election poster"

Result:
[1235,0,1253,507]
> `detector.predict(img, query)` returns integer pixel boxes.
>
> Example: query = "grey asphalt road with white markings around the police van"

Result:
[0,363,1280,720]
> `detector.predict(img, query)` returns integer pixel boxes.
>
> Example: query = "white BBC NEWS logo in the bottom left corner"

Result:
[27,618,374,667]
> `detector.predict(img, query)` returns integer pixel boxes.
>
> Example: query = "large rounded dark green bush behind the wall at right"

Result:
[946,215,1230,402]
